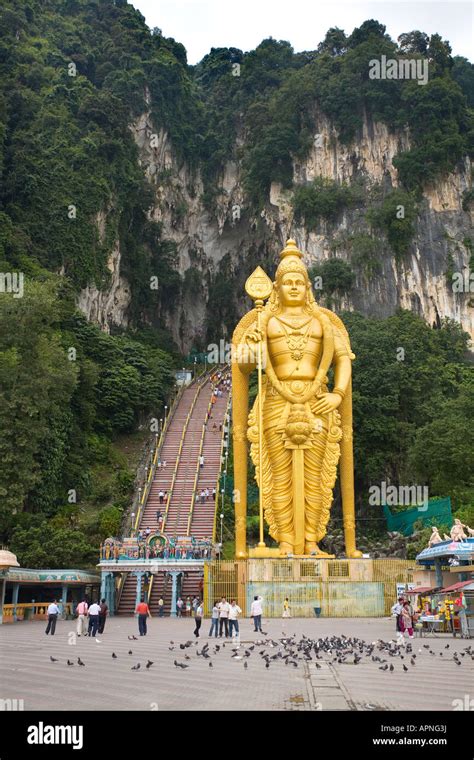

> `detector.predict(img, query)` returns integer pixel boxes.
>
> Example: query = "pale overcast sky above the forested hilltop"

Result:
[132,0,474,64]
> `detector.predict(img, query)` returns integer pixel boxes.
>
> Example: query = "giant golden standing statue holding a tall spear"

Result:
[232,240,361,557]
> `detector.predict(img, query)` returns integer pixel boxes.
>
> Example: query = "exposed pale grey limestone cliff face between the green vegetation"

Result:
[79,112,474,351]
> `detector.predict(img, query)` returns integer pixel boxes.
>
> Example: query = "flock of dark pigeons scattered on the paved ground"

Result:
[45,632,474,673]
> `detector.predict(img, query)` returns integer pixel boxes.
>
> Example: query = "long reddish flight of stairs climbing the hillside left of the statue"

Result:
[118,378,228,615]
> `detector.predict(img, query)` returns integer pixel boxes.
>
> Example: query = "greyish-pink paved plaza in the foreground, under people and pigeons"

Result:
[0,617,474,711]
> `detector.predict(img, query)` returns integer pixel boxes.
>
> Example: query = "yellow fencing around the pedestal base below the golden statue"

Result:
[204,558,414,618]
